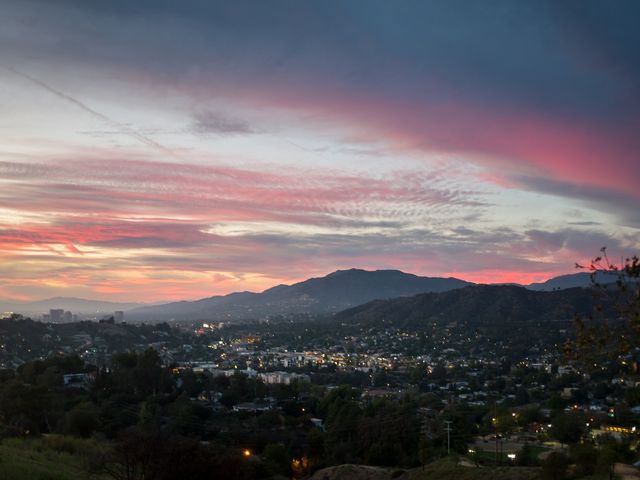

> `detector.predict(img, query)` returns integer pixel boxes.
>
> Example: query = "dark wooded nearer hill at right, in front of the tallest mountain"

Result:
[335,285,596,327]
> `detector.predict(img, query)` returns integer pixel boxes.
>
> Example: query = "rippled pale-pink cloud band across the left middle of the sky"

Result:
[0,158,472,224]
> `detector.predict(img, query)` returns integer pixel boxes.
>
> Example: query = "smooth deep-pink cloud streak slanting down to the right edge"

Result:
[204,79,640,203]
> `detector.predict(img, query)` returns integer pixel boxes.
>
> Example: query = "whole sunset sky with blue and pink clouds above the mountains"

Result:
[0,0,640,302]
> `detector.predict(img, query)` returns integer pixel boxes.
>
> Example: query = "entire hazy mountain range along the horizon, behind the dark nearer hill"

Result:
[0,269,615,322]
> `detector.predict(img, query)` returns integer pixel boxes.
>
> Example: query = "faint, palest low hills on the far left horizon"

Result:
[0,297,142,315]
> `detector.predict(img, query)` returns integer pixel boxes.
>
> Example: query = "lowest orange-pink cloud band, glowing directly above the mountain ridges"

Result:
[0,219,621,301]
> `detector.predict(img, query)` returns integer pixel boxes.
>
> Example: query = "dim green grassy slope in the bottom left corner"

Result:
[0,435,108,480]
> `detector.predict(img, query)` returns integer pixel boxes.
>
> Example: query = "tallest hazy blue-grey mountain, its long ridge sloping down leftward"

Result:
[127,269,471,321]
